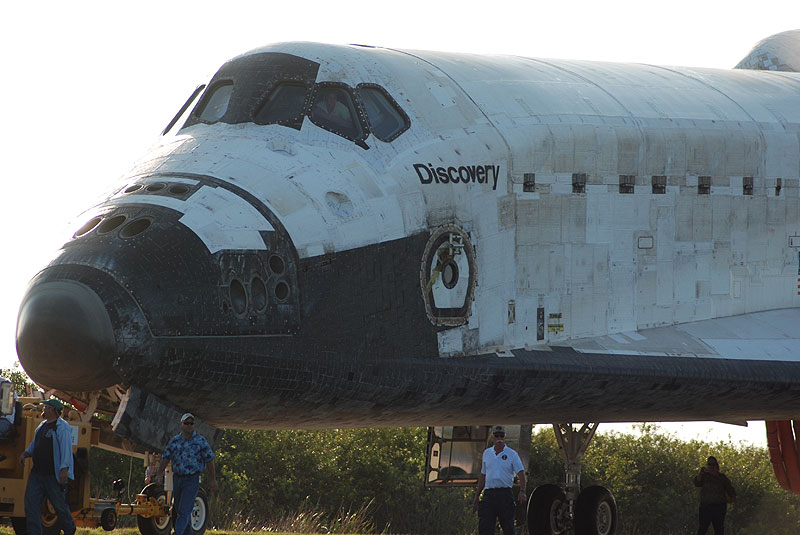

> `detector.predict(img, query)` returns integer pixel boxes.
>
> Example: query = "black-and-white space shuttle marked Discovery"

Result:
[12,30,800,535]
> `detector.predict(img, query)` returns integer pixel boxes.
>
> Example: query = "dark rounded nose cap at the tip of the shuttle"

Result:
[17,281,120,392]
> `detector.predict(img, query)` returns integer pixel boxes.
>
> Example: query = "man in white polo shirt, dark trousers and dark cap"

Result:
[472,425,526,535]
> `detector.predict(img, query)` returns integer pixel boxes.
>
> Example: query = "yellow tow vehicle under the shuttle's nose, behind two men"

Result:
[0,394,208,535]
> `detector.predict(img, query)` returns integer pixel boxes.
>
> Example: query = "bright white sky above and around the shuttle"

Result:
[0,0,800,443]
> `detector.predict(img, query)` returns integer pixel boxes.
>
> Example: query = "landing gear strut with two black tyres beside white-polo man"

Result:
[528,423,617,535]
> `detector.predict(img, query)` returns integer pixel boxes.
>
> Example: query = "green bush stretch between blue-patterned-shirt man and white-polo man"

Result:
[212,428,474,534]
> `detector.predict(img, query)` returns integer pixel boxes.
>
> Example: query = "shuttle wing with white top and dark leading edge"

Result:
[440,308,800,423]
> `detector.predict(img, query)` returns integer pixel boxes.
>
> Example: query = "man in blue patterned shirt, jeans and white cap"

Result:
[153,412,218,535]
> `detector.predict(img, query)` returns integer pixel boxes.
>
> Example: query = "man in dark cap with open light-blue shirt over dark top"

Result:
[19,398,75,535]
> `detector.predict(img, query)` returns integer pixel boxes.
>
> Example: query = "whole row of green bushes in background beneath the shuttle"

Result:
[59,424,800,535]
